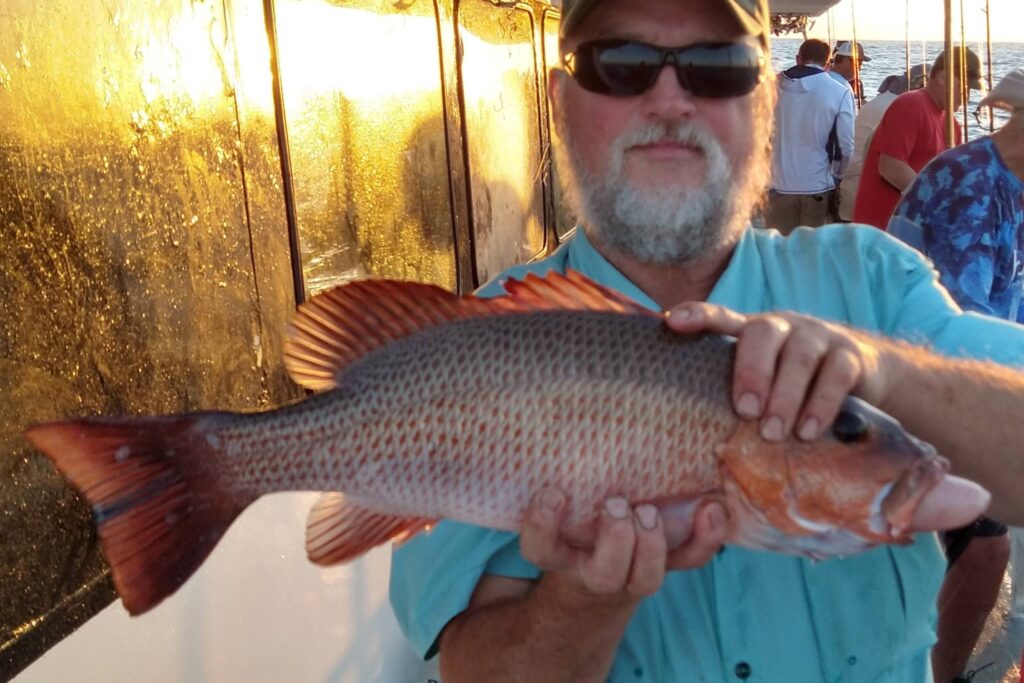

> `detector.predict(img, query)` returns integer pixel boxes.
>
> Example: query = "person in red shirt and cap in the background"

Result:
[853,47,981,229]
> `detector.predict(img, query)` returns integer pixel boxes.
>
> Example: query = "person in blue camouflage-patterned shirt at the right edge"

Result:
[889,69,1024,682]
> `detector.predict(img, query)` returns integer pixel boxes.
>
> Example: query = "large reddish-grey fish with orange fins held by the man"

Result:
[25,270,979,614]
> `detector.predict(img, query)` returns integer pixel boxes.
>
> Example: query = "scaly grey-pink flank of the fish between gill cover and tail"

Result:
[197,311,736,528]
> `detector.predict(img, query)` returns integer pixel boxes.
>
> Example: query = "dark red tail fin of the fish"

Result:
[25,413,251,614]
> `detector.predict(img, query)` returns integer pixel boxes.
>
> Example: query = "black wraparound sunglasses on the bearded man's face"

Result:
[564,39,765,98]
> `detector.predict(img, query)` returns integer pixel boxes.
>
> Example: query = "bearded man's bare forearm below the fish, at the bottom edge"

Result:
[440,574,636,683]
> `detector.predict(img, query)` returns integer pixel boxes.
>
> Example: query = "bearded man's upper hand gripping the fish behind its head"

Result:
[668,302,895,440]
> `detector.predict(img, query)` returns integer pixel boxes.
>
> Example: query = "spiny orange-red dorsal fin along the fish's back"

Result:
[285,270,656,391]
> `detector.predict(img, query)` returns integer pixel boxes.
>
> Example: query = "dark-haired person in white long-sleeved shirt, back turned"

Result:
[765,39,855,233]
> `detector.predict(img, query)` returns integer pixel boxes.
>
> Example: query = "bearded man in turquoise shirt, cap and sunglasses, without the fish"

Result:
[391,0,1024,683]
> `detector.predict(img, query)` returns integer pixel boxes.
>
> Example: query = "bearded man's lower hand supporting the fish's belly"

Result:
[519,488,727,602]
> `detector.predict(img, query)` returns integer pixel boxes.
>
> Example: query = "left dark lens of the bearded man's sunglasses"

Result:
[573,41,664,96]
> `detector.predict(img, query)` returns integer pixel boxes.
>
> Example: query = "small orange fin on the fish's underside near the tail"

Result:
[306,493,437,565]
